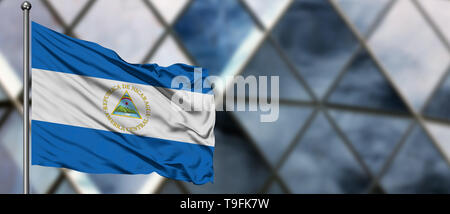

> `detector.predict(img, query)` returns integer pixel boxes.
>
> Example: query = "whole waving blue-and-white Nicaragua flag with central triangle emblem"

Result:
[31,22,215,184]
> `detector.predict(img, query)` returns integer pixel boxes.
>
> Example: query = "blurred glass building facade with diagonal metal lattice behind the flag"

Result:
[0,0,450,193]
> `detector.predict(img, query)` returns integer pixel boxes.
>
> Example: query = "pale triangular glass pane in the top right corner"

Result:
[419,0,450,41]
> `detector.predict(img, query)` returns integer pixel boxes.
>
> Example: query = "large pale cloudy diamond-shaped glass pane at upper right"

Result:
[370,1,450,110]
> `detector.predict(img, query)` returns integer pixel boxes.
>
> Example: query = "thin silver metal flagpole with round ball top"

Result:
[21,1,31,194]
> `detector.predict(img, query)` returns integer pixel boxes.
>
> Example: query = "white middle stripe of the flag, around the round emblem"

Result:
[32,68,215,146]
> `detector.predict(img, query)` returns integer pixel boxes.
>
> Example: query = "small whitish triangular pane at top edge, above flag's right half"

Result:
[150,0,188,23]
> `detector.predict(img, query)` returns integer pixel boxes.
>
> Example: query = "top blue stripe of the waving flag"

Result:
[31,22,212,93]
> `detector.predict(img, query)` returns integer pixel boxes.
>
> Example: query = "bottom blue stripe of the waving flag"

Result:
[31,120,214,184]
